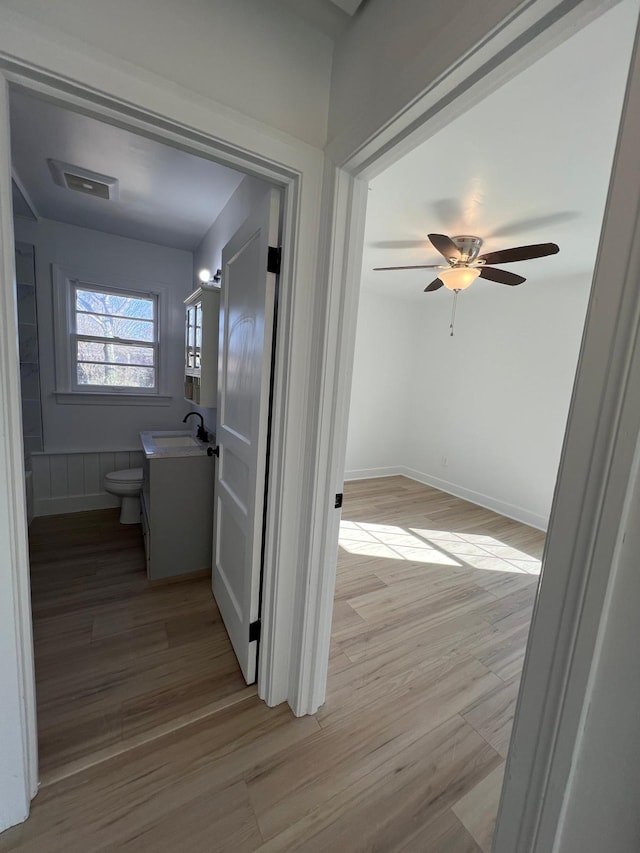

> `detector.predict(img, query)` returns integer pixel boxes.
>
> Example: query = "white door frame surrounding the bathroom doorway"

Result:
[0,15,325,831]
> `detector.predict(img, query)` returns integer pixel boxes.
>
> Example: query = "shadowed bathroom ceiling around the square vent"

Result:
[10,91,244,251]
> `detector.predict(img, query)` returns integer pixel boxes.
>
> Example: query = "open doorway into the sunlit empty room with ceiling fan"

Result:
[328,3,637,851]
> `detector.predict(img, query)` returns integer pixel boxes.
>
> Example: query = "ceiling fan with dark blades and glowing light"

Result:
[374,234,560,294]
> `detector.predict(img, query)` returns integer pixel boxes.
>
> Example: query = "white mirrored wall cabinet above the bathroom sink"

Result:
[184,286,220,408]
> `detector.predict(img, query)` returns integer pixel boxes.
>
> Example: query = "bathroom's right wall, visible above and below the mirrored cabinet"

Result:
[186,176,270,432]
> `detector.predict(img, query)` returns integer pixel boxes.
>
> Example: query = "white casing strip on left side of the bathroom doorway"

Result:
[0,71,38,832]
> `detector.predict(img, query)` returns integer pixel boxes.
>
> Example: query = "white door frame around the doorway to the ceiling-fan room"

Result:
[299,5,640,853]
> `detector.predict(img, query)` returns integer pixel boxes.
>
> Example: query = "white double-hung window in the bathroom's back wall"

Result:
[70,282,158,393]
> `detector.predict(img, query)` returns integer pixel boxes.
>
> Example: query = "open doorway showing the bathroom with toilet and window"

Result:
[10,90,281,785]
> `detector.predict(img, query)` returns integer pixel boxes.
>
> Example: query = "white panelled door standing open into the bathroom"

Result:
[212,190,280,684]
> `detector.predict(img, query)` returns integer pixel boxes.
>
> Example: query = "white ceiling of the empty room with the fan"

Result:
[362,0,639,299]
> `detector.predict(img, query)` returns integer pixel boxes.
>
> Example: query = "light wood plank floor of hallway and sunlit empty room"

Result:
[0,478,543,853]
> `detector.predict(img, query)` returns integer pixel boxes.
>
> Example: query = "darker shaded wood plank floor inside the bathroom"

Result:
[29,510,255,784]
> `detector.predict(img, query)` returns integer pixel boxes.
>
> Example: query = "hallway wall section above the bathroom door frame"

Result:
[2,0,333,148]
